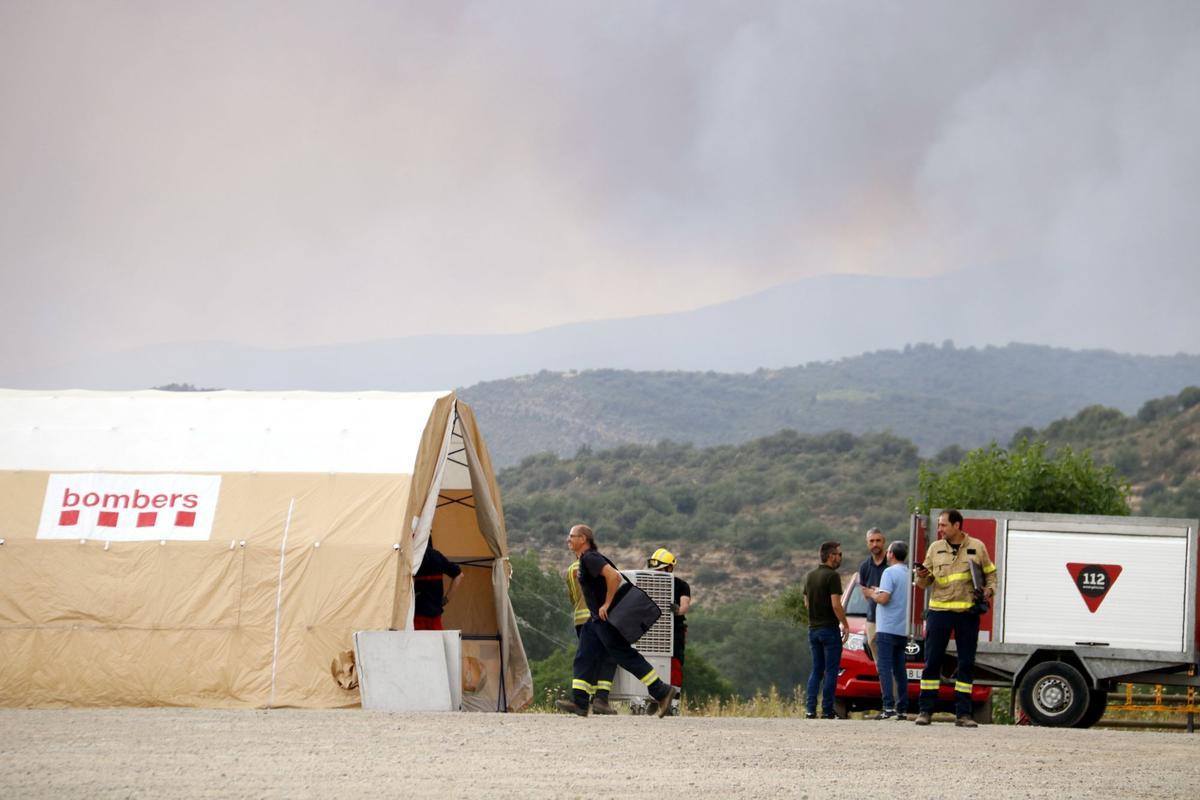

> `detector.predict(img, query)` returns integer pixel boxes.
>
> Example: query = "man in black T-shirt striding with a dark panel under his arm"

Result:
[557,525,674,717]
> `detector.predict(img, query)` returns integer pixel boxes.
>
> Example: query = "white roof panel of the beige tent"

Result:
[0,390,450,475]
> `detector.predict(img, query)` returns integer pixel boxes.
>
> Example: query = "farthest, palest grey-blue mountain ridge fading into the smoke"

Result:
[14,270,1194,397]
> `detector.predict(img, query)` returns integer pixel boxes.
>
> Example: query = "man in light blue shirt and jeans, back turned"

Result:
[863,541,912,720]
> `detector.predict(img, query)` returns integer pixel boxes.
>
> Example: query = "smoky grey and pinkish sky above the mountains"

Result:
[0,0,1200,383]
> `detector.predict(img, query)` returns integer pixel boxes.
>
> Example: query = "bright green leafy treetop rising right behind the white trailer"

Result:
[910,440,1130,515]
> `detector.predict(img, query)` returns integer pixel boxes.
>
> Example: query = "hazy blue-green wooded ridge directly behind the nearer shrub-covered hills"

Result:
[461,342,1200,464]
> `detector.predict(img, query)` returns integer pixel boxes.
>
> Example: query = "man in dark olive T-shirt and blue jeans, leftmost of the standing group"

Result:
[804,542,850,720]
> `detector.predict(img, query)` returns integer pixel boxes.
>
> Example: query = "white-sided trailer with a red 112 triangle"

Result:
[910,510,1200,727]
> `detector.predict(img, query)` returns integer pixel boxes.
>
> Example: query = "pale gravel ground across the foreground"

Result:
[0,709,1200,800]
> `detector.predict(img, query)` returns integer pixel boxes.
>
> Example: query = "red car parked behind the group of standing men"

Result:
[834,575,991,722]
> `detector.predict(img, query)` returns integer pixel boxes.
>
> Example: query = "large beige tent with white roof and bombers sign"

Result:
[0,391,533,710]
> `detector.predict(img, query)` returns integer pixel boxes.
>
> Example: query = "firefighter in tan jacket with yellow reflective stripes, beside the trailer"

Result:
[917,509,996,728]
